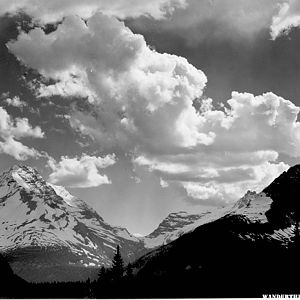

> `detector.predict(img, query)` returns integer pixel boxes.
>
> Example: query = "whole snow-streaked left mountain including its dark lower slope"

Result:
[0,166,144,282]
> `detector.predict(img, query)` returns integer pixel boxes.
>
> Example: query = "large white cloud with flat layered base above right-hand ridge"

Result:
[133,92,300,202]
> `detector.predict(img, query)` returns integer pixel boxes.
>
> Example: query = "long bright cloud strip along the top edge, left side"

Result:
[0,0,186,23]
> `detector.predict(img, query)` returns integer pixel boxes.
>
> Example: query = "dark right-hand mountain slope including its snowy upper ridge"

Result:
[129,165,300,298]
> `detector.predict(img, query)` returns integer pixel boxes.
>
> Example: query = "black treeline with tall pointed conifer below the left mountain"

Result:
[0,246,138,298]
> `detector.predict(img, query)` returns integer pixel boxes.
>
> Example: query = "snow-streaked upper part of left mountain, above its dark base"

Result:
[0,166,144,274]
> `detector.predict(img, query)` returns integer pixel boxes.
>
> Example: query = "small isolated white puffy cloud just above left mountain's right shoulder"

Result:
[48,154,116,188]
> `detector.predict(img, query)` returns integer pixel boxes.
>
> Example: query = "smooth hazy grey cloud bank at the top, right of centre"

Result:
[130,0,284,48]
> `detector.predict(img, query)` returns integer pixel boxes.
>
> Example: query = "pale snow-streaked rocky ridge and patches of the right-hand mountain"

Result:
[141,186,295,249]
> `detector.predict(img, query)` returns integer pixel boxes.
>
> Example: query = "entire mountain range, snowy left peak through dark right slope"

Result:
[0,165,300,297]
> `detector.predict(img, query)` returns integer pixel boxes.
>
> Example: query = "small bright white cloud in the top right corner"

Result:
[271,0,300,39]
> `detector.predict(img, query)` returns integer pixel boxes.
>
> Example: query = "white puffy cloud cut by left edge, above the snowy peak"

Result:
[0,107,44,160]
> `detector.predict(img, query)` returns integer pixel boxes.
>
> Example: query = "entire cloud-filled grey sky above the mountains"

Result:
[0,0,300,234]
